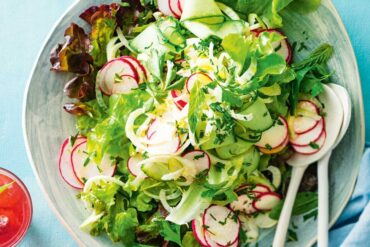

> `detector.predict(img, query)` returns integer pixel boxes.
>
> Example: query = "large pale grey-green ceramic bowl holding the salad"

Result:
[23,0,364,246]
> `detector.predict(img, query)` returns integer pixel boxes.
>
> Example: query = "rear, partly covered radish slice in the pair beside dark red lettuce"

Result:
[96,58,138,95]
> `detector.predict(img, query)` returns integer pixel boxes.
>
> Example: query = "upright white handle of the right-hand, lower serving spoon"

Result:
[317,152,331,247]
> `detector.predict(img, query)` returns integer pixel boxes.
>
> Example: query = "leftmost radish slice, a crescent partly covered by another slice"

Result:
[59,136,86,189]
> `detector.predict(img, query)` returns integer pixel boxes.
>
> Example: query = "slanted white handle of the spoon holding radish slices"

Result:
[272,166,307,247]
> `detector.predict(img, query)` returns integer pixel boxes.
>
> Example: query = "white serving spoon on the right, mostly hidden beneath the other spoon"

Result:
[317,83,352,247]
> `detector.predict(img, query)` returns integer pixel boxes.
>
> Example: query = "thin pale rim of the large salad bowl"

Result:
[22,0,365,247]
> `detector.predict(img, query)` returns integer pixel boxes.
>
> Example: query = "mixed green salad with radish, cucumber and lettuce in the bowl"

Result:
[50,0,333,247]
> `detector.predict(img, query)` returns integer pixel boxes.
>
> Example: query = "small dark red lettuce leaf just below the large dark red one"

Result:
[64,75,95,101]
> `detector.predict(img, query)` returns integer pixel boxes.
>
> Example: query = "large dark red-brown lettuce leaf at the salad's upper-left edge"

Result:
[50,23,93,75]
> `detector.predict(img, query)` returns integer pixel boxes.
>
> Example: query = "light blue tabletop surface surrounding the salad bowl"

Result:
[0,0,370,247]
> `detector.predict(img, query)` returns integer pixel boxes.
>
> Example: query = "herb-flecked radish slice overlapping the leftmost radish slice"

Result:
[70,141,116,183]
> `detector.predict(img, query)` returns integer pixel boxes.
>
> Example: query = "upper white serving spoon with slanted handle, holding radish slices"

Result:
[272,85,343,247]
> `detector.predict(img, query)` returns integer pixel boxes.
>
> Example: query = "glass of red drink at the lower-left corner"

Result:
[0,168,32,247]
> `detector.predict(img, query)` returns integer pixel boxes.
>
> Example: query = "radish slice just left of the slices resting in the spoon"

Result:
[256,117,288,149]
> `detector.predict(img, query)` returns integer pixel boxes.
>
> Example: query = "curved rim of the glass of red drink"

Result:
[0,167,33,247]
